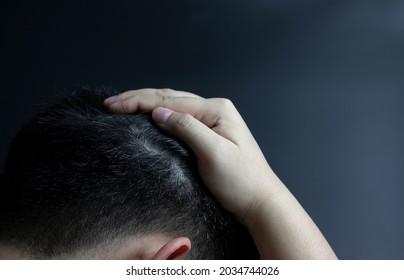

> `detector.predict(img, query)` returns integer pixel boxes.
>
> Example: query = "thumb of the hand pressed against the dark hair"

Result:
[152,107,223,159]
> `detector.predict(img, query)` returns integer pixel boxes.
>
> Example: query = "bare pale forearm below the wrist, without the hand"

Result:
[244,174,337,259]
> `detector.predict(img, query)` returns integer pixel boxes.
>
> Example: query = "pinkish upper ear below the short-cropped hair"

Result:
[152,237,191,260]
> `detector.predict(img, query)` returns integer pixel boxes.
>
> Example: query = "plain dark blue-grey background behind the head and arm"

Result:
[0,0,404,259]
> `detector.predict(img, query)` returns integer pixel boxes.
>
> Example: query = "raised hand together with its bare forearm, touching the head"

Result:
[104,89,337,259]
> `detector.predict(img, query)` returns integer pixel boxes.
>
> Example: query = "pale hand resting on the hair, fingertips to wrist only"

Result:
[105,89,279,222]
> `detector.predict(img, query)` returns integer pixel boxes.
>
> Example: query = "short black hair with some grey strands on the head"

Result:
[0,88,258,259]
